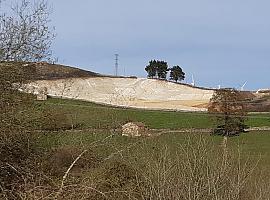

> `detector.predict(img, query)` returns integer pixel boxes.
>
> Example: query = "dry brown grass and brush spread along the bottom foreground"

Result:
[3,136,270,200]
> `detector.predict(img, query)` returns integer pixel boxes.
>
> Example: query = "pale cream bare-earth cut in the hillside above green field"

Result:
[26,77,214,111]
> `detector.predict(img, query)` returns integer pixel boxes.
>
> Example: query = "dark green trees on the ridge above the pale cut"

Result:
[145,60,185,82]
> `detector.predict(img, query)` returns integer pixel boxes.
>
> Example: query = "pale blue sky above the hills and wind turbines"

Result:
[18,0,270,90]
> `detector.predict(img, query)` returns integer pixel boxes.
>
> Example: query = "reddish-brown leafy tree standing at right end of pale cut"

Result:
[208,88,247,136]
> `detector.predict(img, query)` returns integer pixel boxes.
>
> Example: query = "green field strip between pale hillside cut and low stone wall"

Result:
[38,98,270,129]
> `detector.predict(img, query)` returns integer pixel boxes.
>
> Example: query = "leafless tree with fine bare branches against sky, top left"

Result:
[0,0,55,61]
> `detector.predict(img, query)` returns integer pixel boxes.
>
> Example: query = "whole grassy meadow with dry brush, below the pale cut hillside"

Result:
[0,98,270,200]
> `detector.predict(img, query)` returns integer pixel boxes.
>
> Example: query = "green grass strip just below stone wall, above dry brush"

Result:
[39,130,270,160]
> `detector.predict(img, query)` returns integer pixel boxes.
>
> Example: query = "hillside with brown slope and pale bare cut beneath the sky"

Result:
[0,62,270,112]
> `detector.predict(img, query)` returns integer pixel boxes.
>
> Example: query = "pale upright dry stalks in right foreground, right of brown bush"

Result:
[130,137,270,200]
